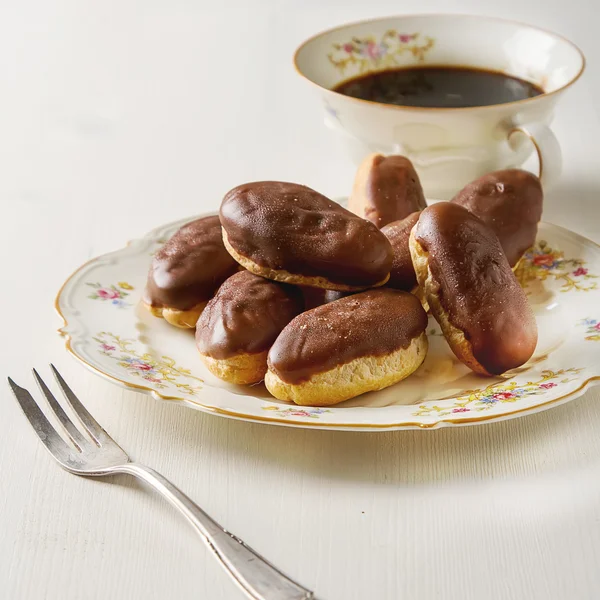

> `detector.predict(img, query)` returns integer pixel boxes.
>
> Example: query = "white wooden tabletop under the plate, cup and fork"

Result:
[0,0,600,600]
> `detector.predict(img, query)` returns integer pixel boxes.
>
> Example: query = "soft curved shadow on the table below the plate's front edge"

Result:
[112,382,600,485]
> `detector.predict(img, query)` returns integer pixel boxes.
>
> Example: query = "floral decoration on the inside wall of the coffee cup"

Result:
[327,29,435,74]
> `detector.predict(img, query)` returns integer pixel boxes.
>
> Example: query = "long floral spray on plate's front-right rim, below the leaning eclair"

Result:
[413,368,582,417]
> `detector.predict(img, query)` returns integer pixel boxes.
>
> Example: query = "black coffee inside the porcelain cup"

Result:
[333,66,544,108]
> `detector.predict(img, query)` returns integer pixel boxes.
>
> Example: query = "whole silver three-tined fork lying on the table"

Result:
[8,365,314,600]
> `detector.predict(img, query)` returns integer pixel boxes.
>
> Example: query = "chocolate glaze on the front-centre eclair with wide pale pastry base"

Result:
[268,288,427,384]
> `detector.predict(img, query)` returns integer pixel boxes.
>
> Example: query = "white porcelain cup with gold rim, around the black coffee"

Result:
[294,14,585,199]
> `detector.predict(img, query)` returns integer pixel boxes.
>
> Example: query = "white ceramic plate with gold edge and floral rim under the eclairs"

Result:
[56,213,600,431]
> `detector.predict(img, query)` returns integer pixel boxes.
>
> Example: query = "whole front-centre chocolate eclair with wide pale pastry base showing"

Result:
[265,288,427,406]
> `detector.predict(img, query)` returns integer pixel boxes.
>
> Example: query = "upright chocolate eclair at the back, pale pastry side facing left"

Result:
[348,154,427,229]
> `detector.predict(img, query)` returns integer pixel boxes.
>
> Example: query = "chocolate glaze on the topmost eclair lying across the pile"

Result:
[220,181,392,287]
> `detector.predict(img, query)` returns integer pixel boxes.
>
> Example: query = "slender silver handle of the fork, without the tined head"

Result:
[111,462,314,600]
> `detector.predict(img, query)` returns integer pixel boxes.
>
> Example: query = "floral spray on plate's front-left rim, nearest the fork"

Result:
[94,331,203,395]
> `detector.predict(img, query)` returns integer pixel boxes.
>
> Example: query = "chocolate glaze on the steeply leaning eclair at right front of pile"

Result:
[415,202,537,374]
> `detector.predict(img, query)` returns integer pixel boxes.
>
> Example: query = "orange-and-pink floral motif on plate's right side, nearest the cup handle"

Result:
[515,240,598,292]
